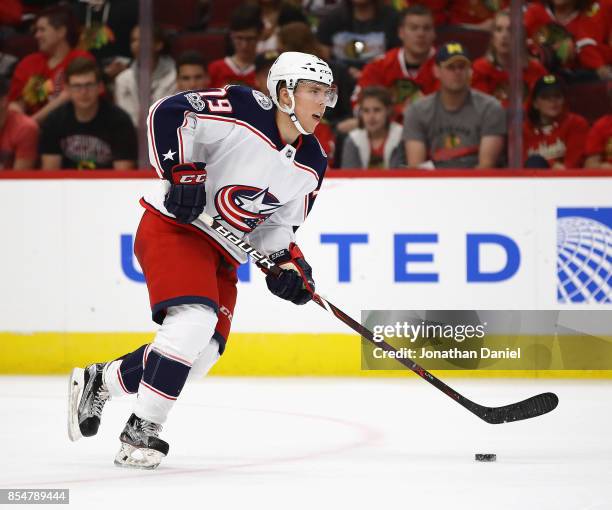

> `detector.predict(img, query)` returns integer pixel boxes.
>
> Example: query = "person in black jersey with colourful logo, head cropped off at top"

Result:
[72,0,138,79]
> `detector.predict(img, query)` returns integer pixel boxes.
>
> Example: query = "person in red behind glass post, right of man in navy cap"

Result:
[472,11,548,108]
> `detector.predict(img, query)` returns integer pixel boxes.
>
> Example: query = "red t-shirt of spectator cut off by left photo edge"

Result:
[0,110,38,170]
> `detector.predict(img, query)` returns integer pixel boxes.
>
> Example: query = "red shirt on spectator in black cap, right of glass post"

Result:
[523,113,589,168]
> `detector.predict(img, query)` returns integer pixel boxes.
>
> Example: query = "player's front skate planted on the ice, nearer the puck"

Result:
[115,414,170,469]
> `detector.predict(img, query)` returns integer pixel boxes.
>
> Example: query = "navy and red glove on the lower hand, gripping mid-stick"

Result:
[266,243,315,305]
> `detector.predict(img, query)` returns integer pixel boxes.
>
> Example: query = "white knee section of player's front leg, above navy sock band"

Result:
[151,304,217,365]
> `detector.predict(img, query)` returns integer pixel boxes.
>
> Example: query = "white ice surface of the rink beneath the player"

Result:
[0,377,612,510]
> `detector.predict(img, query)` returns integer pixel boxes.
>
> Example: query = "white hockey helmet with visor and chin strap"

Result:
[267,51,338,135]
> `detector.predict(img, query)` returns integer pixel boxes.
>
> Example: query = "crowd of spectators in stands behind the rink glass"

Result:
[0,0,612,171]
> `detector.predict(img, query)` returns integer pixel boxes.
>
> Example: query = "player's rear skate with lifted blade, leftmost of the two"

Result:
[68,363,110,441]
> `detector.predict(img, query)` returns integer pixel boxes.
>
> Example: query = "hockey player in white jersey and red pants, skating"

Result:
[68,52,337,469]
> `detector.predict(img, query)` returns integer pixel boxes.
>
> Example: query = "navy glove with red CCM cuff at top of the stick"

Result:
[164,163,206,223]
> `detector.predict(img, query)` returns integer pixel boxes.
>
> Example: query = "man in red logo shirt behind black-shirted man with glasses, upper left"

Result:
[9,7,93,123]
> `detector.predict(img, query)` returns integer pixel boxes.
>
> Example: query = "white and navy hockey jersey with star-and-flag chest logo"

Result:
[141,85,327,263]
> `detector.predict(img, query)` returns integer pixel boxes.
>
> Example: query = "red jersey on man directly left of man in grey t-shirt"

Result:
[351,48,439,120]
